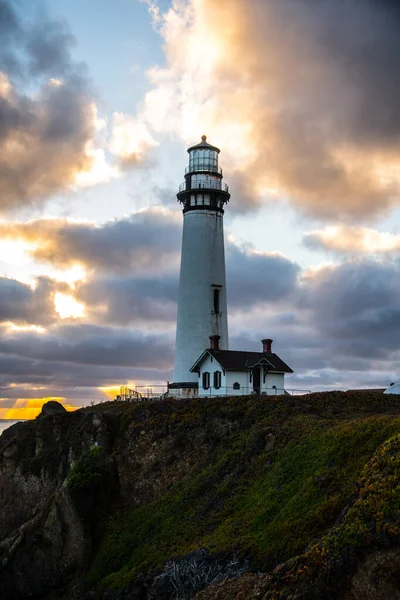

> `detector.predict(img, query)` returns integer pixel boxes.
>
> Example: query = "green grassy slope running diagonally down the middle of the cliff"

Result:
[80,392,400,587]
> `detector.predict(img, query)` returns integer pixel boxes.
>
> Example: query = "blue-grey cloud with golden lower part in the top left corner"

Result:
[0,0,94,212]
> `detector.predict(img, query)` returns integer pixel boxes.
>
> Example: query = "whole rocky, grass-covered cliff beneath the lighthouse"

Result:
[0,392,400,600]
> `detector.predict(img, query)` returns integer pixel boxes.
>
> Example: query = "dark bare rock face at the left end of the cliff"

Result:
[0,409,117,600]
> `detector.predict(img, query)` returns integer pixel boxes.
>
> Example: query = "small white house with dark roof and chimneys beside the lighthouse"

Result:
[190,335,293,396]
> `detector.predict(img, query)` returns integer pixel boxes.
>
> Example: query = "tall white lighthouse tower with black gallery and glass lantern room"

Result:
[169,135,230,396]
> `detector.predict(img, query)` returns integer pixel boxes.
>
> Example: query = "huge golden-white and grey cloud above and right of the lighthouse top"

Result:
[139,0,400,218]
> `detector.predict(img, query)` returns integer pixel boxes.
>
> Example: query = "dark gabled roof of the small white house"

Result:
[190,350,293,373]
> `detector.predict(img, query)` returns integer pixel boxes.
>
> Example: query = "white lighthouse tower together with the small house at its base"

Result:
[168,135,293,397]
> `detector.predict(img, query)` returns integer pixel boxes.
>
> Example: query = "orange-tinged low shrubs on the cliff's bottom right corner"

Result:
[264,434,400,600]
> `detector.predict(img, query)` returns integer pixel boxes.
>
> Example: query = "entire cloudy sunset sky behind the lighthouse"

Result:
[0,0,400,419]
